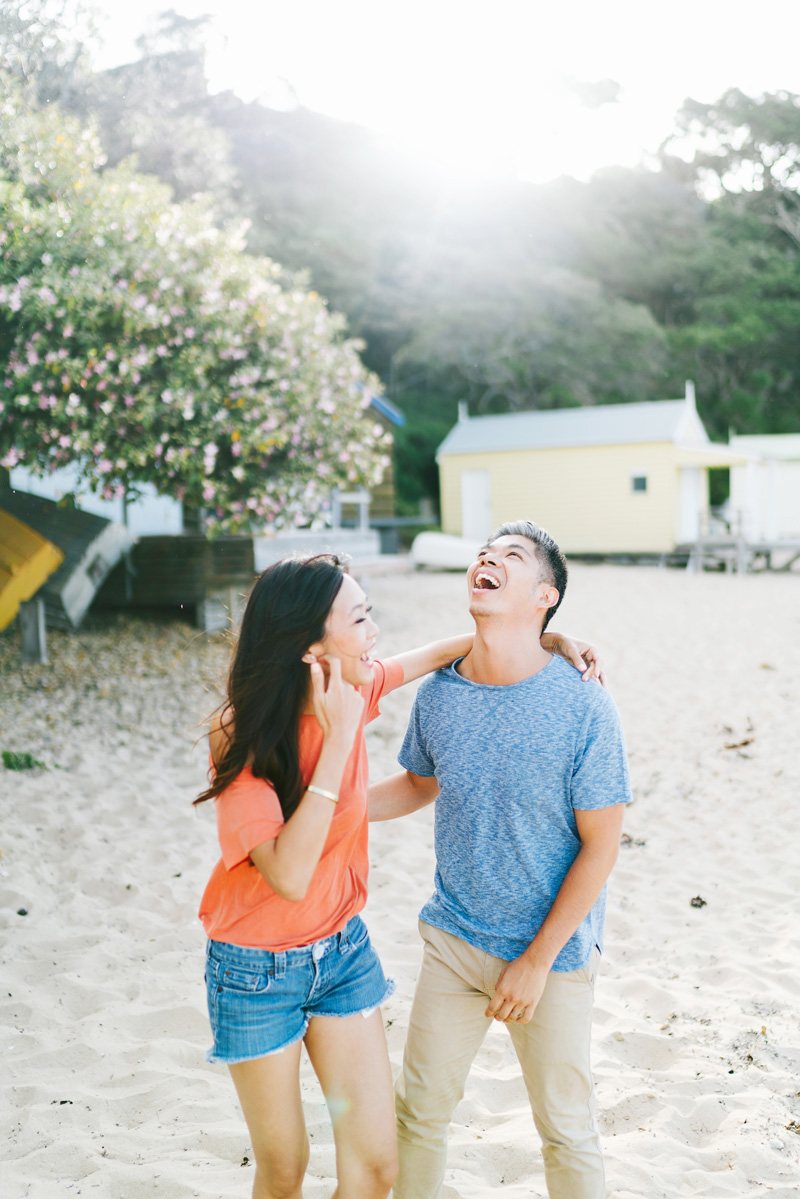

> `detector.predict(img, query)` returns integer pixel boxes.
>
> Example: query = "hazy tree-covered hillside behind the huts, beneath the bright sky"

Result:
[1,4,800,511]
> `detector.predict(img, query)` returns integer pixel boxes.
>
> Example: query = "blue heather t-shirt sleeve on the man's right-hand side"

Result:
[571,683,631,812]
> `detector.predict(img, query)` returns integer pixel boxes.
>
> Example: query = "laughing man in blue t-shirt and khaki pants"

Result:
[369,522,630,1199]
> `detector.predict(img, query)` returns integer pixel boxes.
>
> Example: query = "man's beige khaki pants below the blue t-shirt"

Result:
[393,921,606,1199]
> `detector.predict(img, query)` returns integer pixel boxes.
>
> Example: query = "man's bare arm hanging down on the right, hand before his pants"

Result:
[486,803,625,1024]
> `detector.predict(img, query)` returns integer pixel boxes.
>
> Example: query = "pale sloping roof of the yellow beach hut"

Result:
[437,399,708,457]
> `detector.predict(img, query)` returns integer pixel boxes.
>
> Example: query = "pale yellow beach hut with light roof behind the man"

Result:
[437,382,747,555]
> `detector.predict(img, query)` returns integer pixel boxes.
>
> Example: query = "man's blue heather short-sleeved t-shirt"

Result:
[398,657,631,970]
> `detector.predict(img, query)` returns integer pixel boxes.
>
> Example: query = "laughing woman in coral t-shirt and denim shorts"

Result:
[196,554,597,1199]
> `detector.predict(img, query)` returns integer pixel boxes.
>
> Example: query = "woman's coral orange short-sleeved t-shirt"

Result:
[199,658,403,952]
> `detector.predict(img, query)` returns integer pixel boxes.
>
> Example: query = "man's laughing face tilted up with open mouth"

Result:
[467,534,558,621]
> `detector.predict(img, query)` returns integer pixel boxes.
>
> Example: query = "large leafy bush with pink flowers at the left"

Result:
[0,89,387,531]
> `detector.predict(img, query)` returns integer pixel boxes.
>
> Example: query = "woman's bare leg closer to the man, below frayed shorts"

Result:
[306,1011,397,1199]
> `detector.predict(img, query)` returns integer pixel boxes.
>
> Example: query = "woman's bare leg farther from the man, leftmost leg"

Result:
[228,1041,308,1199]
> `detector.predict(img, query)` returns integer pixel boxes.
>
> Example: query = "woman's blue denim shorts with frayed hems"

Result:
[205,916,395,1065]
